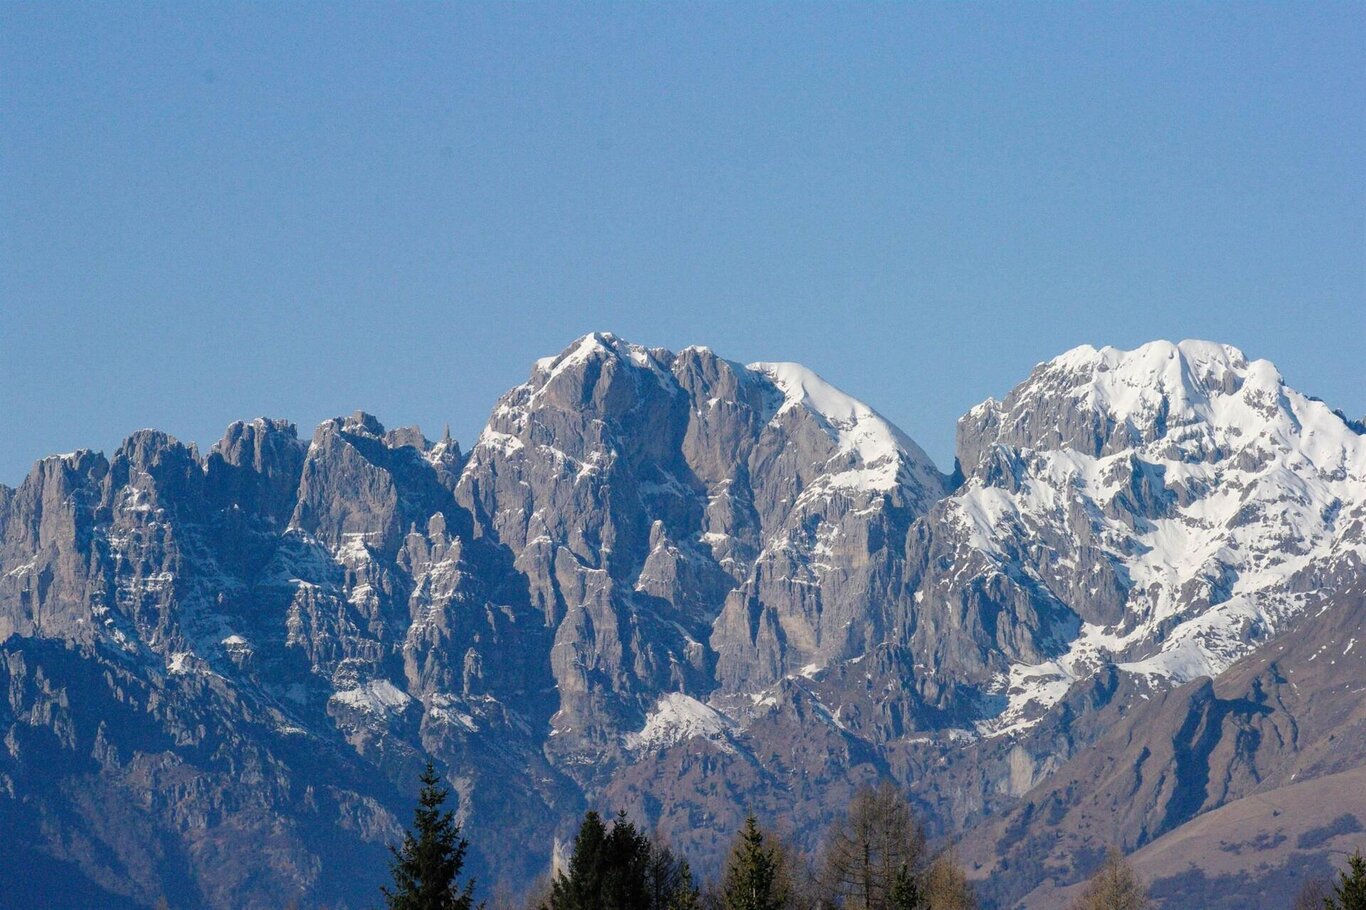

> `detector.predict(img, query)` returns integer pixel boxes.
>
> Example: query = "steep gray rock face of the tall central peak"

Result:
[458,335,945,753]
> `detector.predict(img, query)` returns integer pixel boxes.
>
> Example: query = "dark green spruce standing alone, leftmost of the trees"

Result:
[380,761,474,910]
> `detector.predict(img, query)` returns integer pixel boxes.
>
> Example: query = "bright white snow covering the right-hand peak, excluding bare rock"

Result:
[952,342,1366,730]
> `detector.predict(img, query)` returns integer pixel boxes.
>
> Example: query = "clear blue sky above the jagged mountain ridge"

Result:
[0,3,1366,485]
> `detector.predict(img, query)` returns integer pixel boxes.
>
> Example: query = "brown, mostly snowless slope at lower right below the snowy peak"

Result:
[964,562,1366,909]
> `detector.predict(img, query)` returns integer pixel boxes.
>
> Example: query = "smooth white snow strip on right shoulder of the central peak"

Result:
[746,362,943,491]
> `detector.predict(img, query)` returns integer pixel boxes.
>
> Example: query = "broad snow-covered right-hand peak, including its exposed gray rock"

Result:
[948,342,1366,726]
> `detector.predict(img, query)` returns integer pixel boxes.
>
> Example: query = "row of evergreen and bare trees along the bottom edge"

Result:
[381,764,1366,910]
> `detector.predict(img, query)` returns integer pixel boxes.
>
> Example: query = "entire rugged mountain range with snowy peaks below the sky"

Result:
[0,333,1366,909]
